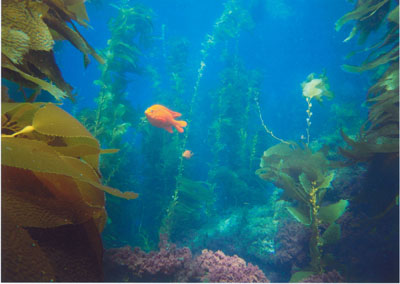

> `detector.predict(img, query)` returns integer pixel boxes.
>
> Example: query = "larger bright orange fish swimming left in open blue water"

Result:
[144,105,187,133]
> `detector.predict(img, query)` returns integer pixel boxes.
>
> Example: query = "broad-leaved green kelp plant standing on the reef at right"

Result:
[256,142,348,274]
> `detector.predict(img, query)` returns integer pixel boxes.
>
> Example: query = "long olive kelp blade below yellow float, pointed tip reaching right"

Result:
[1,137,138,199]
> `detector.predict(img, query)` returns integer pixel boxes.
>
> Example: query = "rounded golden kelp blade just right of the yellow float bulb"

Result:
[33,103,95,140]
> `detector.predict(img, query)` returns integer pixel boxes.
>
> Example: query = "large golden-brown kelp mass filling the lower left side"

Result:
[1,103,137,281]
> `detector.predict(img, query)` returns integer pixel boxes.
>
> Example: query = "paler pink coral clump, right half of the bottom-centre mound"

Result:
[195,249,269,283]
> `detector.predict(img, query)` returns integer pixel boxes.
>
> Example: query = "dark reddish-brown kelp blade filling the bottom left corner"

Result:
[1,213,56,282]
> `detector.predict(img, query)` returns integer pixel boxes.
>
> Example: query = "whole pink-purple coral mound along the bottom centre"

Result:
[104,235,269,282]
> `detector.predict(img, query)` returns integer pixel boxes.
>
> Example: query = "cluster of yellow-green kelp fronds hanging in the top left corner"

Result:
[1,0,104,102]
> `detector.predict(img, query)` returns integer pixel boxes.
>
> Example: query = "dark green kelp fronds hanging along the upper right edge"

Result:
[336,0,399,161]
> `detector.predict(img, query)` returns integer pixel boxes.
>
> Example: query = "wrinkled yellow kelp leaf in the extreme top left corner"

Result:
[1,0,54,51]
